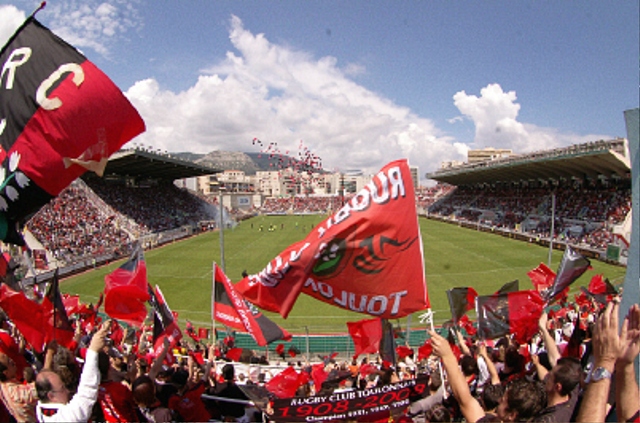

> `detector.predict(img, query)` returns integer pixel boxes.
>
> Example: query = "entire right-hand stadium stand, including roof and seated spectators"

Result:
[423,139,631,258]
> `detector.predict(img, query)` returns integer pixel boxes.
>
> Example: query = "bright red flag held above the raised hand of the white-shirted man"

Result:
[104,245,149,327]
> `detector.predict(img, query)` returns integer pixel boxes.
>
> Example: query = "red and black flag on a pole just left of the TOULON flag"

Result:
[211,263,291,347]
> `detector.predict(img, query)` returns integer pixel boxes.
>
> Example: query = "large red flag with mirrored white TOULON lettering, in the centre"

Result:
[236,160,429,319]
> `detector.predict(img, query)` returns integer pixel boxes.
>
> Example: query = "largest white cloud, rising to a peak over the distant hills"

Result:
[127,16,463,179]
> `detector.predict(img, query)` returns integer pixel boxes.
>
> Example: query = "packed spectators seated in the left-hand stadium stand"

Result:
[26,179,214,263]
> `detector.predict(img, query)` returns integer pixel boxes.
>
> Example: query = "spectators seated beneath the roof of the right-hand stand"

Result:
[429,179,631,250]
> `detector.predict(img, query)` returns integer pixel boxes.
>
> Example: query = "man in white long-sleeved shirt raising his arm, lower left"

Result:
[36,321,110,423]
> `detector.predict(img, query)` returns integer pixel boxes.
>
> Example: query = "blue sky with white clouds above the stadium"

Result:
[0,0,640,182]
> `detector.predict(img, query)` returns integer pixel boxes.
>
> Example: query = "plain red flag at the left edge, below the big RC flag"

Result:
[0,284,47,353]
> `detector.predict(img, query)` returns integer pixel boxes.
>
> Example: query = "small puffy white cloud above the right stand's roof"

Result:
[453,84,607,153]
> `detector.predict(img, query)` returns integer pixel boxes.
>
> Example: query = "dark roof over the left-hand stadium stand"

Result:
[99,148,222,181]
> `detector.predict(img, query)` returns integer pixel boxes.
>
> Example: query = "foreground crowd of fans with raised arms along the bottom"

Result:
[0,284,640,422]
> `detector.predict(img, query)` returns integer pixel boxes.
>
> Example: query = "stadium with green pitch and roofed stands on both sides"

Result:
[0,139,631,354]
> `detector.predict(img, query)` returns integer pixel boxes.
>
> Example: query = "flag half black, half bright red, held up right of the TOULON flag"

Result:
[476,290,544,344]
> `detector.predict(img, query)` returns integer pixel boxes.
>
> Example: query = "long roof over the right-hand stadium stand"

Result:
[426,138,631,185]
